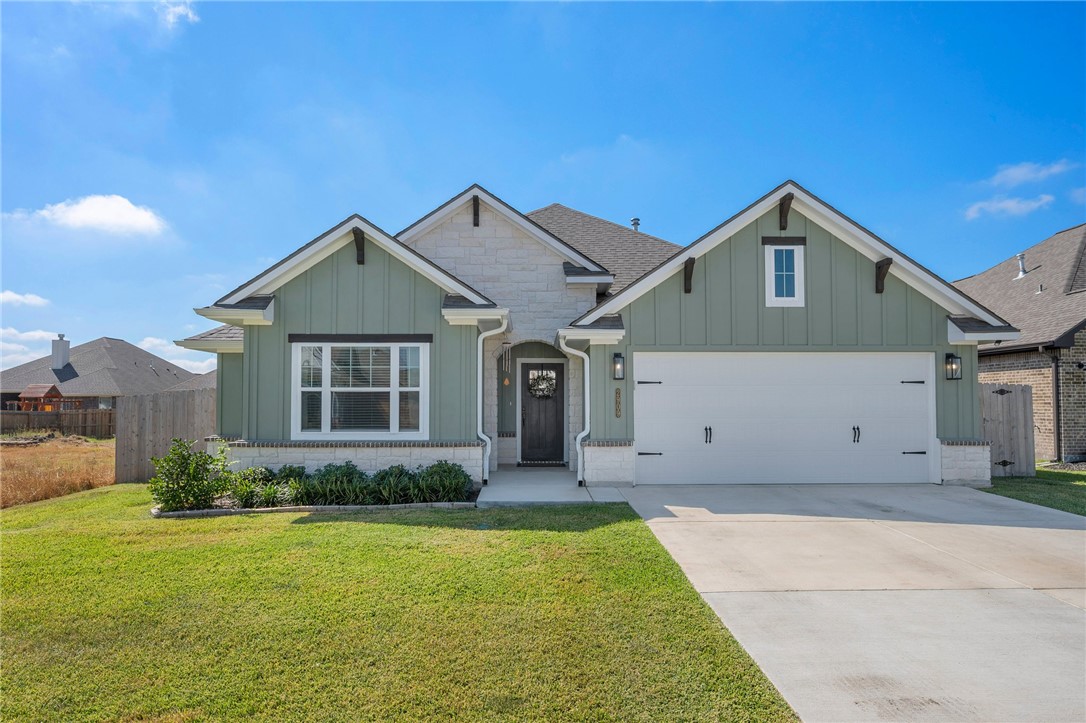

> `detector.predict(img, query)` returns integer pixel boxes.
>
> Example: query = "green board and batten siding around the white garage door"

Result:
[590,208,980,440]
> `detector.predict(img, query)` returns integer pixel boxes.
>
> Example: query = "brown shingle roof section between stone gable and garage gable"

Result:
[526,203,681,292]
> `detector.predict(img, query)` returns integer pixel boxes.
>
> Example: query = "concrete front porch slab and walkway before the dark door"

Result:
[476,465,626,507]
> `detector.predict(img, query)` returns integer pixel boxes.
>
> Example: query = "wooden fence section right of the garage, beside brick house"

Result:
[981,384,1036,478]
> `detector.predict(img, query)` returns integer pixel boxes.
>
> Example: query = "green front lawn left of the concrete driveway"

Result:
[0,485,794,721]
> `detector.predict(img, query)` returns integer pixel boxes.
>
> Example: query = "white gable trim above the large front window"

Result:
[218,214,493,306]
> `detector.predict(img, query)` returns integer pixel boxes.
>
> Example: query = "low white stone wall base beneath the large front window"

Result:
[224,441,482,485]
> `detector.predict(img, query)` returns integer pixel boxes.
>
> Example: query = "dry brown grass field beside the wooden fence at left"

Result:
[0,436,115,507]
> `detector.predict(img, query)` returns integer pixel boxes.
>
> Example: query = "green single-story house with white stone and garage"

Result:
[178,181,1018,485]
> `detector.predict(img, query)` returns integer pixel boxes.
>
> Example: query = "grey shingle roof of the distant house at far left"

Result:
[0,337,194,396]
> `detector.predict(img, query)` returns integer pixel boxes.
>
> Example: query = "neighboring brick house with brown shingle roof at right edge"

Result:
[955,224,1086,461]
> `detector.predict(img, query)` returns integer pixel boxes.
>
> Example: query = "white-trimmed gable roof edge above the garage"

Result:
[573,180,1007,327]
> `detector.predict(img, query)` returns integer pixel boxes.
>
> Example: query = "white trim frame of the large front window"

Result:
[290,342,430,442]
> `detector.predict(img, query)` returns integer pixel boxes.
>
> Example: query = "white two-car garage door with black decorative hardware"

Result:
[633,352,938,484]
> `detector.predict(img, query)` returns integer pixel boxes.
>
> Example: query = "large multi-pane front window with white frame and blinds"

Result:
[292,343,429,440]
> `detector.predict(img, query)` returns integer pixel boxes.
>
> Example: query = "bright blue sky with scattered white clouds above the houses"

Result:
[0,2,1086,370]
